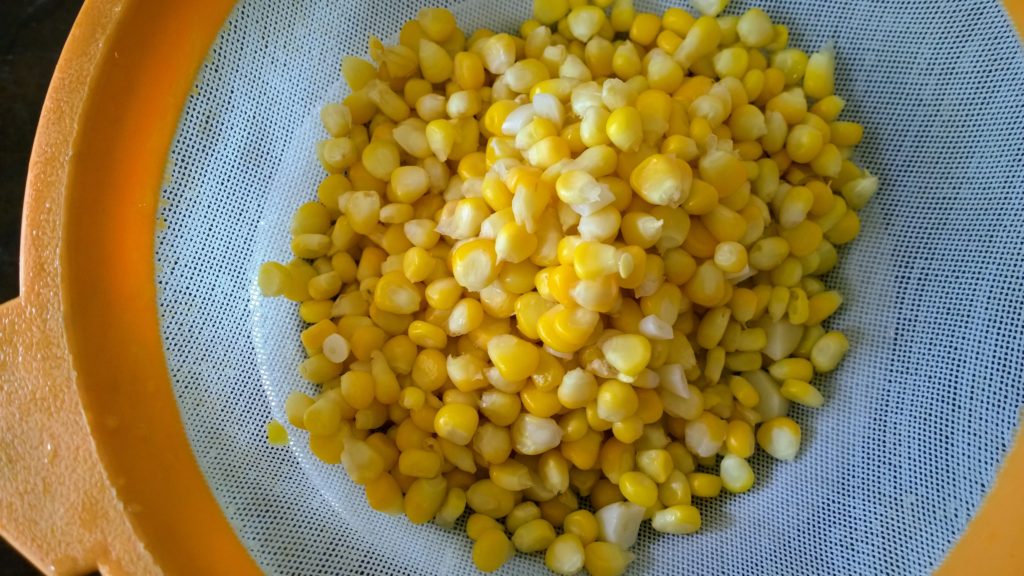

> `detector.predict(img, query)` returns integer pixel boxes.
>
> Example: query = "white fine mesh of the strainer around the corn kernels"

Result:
[157,0,1024,574]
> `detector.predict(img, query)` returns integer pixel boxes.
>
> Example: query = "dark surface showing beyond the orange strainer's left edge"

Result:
[0,0,82,576]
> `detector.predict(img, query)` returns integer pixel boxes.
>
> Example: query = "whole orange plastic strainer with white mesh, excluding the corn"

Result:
[0,0,1024,574]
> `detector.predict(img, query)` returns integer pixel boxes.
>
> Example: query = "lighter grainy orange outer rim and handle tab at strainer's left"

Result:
[0,3,158,574]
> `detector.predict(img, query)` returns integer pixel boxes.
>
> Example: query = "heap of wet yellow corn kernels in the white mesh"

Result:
[259,0,878,576]
